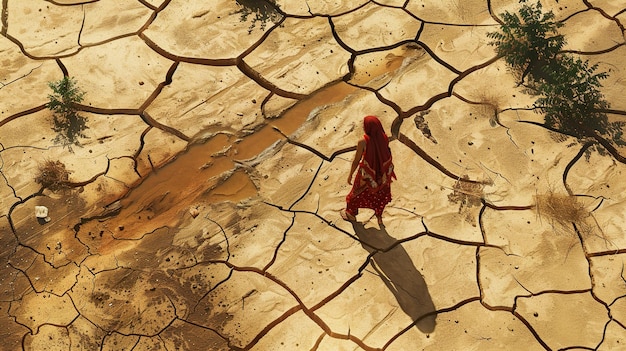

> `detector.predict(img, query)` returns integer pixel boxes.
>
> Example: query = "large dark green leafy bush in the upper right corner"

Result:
[487,0,626,145]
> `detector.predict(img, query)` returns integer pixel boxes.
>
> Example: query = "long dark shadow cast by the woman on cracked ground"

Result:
[352,222,437,333]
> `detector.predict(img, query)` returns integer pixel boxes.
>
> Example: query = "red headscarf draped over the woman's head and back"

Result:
[363,116,395,184]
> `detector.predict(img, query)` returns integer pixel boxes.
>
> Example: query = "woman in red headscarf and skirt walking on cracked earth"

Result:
[341,116,396,225]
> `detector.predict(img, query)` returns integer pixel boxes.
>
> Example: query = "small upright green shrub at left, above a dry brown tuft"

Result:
[47,76,88,151]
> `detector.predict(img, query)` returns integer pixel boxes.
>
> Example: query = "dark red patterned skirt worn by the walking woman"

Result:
[346,166,391,217]
